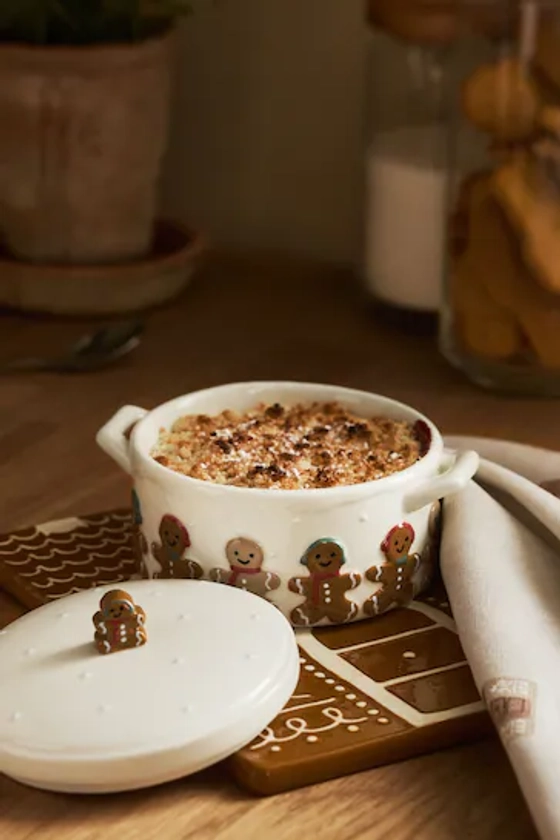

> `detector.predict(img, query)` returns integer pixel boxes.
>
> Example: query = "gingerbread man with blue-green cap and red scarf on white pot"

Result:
[288,538,362,627]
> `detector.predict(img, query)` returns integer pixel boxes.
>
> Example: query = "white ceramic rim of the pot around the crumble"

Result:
[129,380,444,502]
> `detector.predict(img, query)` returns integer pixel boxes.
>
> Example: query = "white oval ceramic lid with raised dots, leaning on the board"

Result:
[0,580,299,793]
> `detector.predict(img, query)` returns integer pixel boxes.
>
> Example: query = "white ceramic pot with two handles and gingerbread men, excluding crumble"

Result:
[97,382,478,626]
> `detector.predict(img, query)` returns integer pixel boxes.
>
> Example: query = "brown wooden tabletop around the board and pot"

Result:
[0,259,560,840]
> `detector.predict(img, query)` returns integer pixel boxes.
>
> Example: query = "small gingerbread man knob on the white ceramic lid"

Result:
[93,589,148,654]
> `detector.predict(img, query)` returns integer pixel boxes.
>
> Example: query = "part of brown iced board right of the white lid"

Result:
[232,591,491,794]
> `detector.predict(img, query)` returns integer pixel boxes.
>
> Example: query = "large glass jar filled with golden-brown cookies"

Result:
[440,0,560,396]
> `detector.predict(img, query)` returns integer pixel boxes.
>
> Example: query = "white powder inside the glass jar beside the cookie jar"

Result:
[365,124,447,311]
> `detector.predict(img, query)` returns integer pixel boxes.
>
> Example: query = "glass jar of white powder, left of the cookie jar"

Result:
[362,0,450,316]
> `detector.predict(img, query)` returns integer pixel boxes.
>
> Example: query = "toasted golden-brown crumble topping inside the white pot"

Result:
[152,402,423,490]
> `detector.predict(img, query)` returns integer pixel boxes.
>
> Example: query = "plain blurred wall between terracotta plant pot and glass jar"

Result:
[164,0,367,263]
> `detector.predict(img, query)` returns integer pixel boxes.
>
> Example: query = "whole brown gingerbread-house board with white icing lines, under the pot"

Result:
[0,510,492,795]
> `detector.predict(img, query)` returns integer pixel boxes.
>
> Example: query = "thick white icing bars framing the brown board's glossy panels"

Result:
[297,601,484,727]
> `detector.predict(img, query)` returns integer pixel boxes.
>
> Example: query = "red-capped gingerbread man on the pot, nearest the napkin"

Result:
[364,522,420,615]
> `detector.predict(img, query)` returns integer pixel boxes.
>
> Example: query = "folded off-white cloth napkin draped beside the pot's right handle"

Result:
[441,437,560,840]
